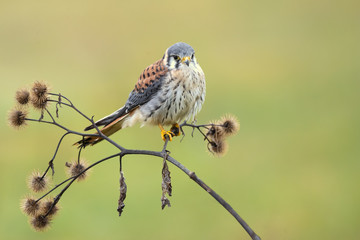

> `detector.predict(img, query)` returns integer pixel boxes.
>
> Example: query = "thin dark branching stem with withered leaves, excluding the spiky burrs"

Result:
[16,87,260,240]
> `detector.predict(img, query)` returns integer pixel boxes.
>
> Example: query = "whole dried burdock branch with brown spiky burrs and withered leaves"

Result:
[9,83,260,240]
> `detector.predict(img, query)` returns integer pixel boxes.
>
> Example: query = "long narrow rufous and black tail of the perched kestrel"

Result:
[74,107,130,148]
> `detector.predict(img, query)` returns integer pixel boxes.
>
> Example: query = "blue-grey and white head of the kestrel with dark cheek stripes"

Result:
[164,42,197,70]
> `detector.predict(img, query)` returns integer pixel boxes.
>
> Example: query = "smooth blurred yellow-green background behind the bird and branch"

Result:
[0,0,360,239]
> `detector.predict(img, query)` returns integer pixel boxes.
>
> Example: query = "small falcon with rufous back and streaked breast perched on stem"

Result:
[77,42,206,147]
